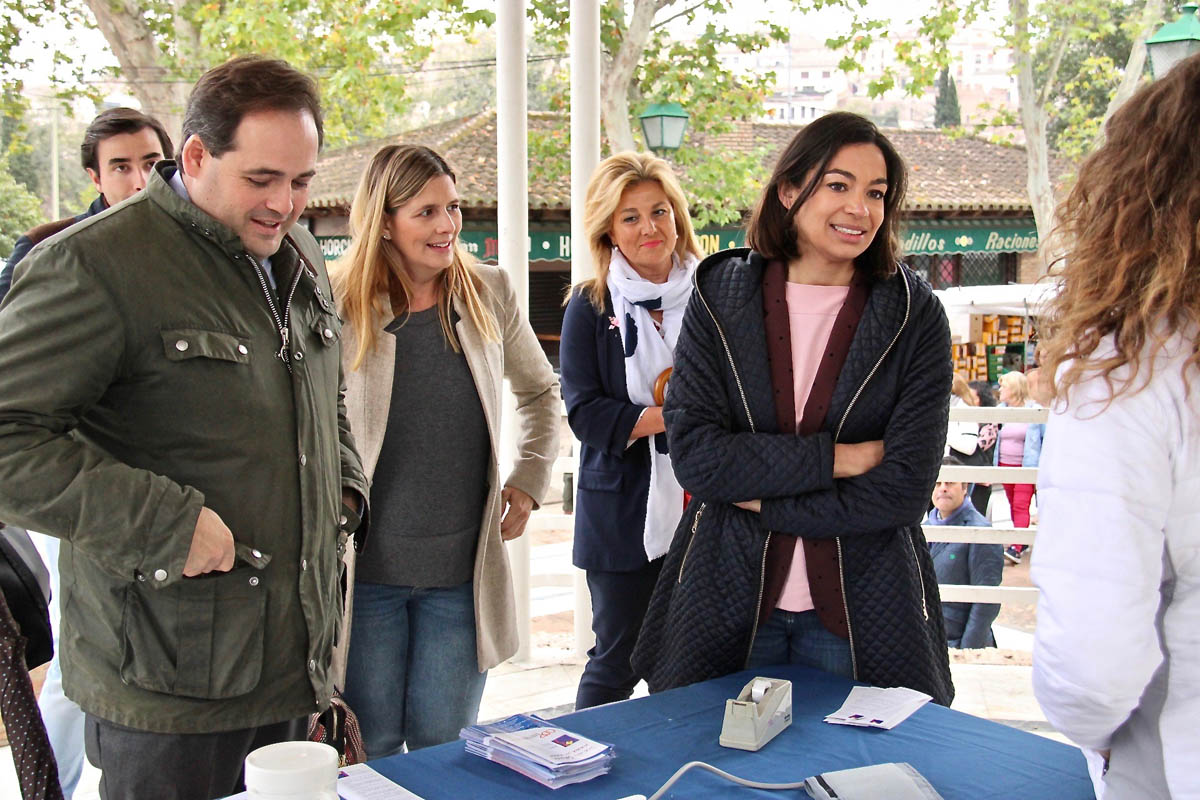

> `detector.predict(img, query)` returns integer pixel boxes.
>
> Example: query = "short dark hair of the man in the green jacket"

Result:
[184,55,325,157]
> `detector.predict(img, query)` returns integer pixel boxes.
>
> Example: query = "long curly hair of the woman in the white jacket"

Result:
[1039,55,1200,407]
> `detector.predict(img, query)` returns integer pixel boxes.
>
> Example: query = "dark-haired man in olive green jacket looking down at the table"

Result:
[0,56,367,800]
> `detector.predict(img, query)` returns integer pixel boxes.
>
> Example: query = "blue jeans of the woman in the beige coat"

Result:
[346,582,487,758]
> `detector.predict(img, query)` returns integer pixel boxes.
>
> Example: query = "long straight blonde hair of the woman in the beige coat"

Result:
[329,144,499,369]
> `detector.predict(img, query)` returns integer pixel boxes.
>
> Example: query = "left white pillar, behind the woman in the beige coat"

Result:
[496,0,532,661]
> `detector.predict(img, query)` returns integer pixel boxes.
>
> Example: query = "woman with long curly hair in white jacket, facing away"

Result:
[1033,51,1200,800]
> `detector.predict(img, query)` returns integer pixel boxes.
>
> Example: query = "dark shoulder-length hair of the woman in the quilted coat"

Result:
[746,112,908,277]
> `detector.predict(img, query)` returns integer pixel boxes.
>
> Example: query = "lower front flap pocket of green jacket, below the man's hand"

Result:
[121,569,266,699]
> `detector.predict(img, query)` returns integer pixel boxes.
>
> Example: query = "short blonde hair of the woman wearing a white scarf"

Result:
[571,151,704,311]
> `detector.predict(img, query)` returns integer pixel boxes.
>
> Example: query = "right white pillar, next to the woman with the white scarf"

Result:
[571,0,600,657]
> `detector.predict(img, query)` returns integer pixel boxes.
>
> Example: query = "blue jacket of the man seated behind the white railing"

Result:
[925,497,1004,648]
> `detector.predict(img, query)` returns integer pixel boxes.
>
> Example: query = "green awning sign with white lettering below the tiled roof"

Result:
[317,219,1038,261]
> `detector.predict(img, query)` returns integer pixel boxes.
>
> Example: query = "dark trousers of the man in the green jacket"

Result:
[84,714,308,800]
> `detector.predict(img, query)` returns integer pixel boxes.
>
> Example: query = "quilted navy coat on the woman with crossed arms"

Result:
[634,248,954,705]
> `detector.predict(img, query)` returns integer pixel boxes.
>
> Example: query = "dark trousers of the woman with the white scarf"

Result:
[575,558,662,710]
